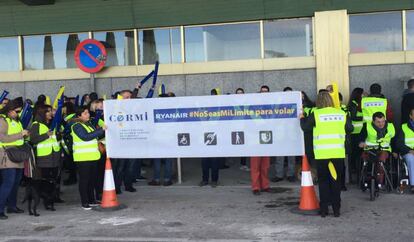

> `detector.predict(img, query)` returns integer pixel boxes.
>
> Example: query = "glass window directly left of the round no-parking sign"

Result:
[23,33,88,70]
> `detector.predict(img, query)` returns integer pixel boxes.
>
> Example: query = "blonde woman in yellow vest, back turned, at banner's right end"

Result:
[300,92,353,217]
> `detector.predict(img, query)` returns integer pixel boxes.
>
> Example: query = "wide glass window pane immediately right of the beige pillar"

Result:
[349,12,402,53]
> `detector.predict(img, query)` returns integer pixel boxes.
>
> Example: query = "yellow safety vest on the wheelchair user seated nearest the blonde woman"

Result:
[365,122,395,152]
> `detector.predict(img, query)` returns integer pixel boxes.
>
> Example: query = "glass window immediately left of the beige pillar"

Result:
[263,19,313,58]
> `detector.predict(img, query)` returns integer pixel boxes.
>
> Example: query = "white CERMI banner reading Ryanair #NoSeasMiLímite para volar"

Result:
[104,92,304,158]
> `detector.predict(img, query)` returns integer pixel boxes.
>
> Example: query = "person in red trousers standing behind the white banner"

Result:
[250,85,270,195]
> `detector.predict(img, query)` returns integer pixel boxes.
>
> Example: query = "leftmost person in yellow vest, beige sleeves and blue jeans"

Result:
[0,100,29,220]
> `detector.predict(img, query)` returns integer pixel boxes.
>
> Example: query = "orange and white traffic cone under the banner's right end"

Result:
[296,155,319,214]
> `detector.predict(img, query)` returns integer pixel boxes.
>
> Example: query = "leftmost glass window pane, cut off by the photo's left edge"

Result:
[0,37,19,71]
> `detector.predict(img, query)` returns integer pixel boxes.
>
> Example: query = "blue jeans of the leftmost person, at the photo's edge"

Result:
[0,168,23,213]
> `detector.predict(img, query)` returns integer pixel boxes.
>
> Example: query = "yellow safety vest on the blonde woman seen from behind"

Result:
[313,107,346,159]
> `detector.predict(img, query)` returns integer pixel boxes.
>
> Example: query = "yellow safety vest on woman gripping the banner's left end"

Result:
[71,123,101,162]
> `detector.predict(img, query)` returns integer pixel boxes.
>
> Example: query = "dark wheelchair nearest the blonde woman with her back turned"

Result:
[359,145,396,201]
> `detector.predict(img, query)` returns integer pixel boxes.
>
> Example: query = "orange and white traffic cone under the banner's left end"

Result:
[96,158,125,210]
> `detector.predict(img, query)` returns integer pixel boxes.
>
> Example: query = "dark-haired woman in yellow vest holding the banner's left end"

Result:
[71,106,106,210]
